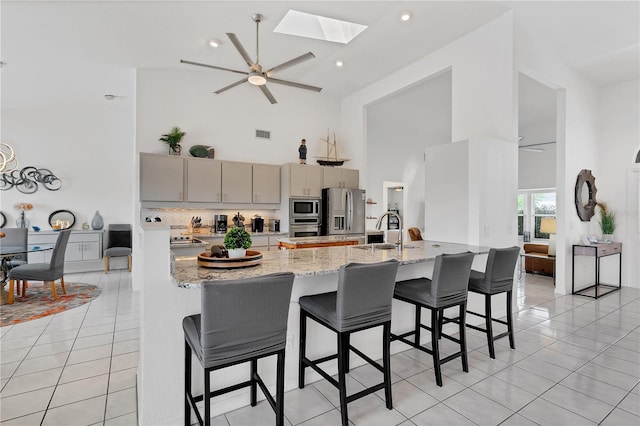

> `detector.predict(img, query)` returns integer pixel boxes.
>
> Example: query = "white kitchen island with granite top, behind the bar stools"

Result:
[138,228,492,425]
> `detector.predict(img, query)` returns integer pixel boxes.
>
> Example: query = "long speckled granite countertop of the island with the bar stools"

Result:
[172,241,489,288]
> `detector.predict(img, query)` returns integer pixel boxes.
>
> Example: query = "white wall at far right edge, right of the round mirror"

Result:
[590,80,640,288]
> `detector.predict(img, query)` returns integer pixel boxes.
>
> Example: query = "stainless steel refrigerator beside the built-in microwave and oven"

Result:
[322,188,366,235]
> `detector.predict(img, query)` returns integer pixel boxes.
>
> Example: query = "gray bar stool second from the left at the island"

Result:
[298,260,398,426]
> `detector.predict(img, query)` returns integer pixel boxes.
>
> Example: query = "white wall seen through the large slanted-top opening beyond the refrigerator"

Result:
[362,71,451,229]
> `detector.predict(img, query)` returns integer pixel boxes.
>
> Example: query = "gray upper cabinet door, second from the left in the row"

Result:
[186,158,222,203]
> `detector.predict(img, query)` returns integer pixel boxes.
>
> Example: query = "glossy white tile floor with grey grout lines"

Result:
[0,271,640,426]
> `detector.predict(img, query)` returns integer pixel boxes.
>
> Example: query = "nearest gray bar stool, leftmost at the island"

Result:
[182,272,294,426]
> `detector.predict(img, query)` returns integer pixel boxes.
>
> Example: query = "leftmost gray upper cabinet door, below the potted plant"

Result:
[140,153,184,201]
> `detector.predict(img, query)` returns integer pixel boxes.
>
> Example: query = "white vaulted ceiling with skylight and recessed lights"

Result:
[0,0,640,98]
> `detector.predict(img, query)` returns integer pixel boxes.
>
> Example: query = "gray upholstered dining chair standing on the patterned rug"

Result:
[8,229,71,304]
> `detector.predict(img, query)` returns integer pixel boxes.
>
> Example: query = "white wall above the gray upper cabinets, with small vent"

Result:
[136,69,342,167]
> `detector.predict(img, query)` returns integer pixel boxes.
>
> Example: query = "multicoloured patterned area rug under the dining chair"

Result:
[0,282,102,327]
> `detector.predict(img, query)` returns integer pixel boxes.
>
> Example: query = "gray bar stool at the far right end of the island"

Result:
[467,246,520,358]
